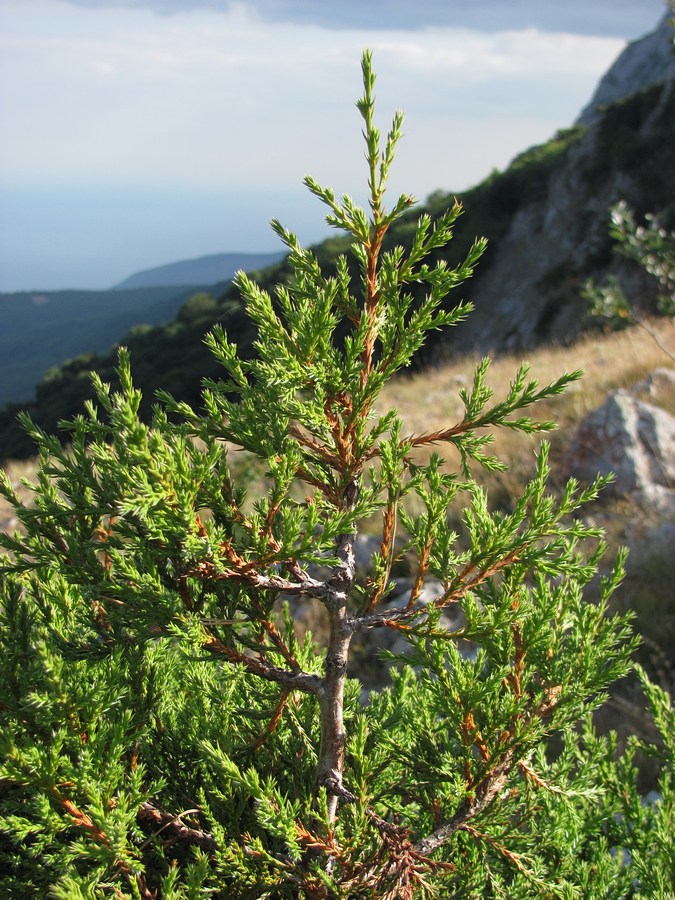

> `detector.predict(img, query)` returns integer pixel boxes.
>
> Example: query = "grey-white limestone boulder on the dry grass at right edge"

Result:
[565,391,675,514]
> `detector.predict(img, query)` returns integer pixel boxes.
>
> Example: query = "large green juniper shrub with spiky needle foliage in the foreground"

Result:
[0,54,675,900]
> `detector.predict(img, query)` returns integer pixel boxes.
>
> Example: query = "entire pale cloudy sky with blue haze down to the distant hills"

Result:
[0,0,665,291]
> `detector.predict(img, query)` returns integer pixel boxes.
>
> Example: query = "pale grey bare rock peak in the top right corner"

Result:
[577,13,675,125]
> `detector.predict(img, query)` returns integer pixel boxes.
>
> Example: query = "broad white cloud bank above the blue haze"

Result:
[0,0,622,195]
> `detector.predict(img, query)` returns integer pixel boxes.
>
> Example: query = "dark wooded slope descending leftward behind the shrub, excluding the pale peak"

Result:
[0,81,675,458]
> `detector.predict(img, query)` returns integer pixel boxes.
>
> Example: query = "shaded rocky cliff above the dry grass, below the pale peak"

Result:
[462,79,675,349]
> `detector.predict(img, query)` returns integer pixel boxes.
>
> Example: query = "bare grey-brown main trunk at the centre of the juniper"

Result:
[316,478,358,822]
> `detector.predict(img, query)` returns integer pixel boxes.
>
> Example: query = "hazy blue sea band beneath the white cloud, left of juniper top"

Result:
[0,181,330,292]
